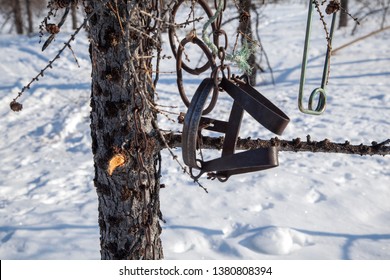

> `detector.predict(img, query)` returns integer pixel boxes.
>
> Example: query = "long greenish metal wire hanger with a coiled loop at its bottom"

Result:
[298,0,336,115]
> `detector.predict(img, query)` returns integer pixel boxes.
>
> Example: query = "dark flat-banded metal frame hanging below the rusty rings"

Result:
[182,76,290,182]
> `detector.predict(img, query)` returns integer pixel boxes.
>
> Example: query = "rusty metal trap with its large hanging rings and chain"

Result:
[169,0,290,182]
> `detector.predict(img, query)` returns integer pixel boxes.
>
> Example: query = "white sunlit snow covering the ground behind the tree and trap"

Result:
[0,4,390,259]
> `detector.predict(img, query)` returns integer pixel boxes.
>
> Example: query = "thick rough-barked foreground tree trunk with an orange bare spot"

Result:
[86,0,163,259]
